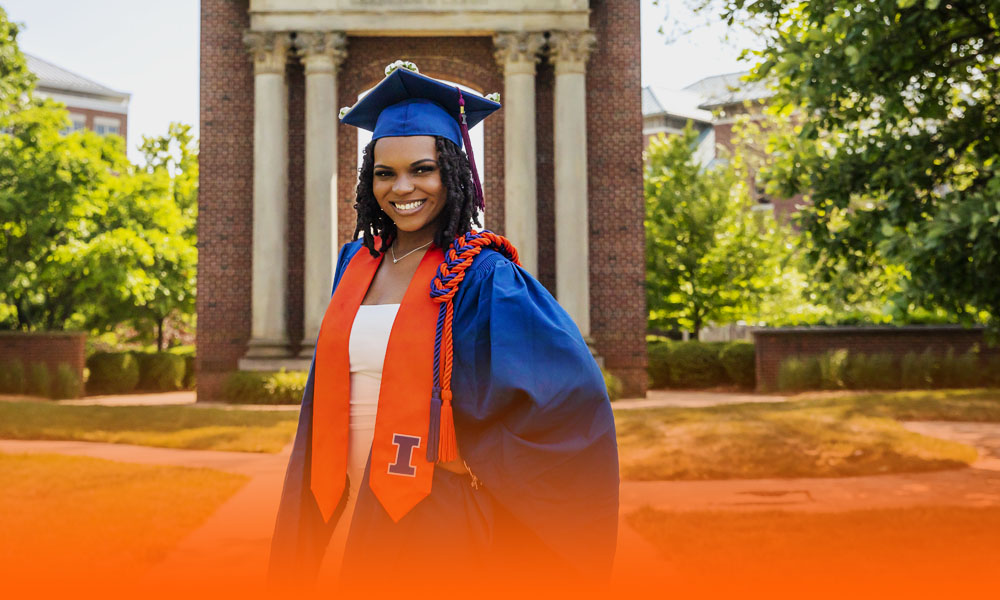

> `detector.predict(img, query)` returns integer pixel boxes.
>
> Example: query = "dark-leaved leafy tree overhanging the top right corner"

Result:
[705,0,1000,326]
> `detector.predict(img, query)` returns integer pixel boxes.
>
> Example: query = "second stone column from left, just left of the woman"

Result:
[295,31,347,358]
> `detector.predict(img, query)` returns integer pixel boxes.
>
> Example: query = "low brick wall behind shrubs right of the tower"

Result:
[752,325,1000,391]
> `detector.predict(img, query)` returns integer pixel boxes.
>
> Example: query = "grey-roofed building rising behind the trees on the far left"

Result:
[24,54,131,142]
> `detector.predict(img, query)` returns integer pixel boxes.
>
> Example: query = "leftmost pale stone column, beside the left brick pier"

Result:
[244,31,291,358]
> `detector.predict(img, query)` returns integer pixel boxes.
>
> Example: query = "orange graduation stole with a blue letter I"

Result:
[310,245,444,521]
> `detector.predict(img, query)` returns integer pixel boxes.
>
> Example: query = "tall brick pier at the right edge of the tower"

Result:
[584,0,647,395]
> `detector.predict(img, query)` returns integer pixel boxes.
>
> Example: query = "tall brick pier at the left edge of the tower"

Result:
[196,0,253,400]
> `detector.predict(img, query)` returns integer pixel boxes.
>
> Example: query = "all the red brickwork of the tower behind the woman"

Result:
[197,0,646,400]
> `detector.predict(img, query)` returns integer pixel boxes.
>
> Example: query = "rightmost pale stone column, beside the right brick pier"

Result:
[549,31,596,337]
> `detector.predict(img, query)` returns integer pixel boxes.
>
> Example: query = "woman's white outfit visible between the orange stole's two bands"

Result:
[347,304,399,499]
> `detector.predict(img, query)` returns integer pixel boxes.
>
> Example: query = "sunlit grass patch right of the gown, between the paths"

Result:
[615,390,980,481]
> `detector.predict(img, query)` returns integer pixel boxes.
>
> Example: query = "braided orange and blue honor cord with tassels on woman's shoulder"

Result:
[427,229,521,462]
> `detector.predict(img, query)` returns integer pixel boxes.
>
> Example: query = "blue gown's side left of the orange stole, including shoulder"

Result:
[268,242,361,587]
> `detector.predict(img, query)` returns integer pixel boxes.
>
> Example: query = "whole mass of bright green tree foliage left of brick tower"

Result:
[0,11,198,346]
